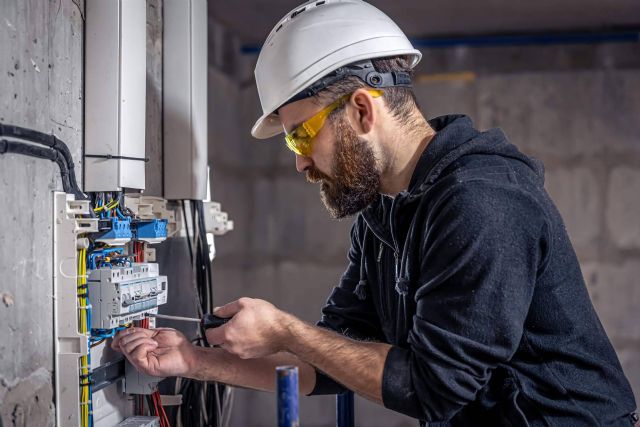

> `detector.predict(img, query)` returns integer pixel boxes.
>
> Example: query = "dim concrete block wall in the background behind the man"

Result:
[209,44,640,427]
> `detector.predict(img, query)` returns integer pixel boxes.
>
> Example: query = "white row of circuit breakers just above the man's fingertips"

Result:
[88,263,167,329]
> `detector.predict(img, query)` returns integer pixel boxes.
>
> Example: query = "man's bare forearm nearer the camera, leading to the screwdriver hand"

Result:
[284,315,391,404]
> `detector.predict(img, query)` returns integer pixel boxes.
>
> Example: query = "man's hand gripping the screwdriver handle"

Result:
[206,298,287,359]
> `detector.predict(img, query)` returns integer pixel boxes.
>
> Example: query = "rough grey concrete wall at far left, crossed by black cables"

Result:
[0,0,83,426]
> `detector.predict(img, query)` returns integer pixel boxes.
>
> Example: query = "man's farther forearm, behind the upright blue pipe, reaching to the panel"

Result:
[186,347,316,395]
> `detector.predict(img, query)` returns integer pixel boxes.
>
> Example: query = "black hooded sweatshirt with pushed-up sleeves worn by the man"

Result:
[312,116,636,427]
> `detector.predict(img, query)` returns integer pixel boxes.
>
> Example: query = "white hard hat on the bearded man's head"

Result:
[251,0,422,139]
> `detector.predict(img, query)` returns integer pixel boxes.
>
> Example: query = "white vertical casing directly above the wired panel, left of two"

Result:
[84,0,147,192]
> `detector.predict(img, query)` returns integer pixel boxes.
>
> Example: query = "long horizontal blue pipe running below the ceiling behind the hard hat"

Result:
[240,29,640,55]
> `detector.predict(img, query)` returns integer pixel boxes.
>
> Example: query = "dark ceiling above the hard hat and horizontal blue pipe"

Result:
[209,0,640,46]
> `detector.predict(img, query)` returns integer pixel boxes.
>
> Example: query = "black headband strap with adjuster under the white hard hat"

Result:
[278,59,412,108]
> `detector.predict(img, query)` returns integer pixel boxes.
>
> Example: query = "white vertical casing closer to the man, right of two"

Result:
[162,0,208,200]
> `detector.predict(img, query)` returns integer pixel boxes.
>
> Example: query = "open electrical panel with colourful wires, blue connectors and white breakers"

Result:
[54,192,175,427]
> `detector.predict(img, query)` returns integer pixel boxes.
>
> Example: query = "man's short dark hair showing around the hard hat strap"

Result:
[315,56,420,126]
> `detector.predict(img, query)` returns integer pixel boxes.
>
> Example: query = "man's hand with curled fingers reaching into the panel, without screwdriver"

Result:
[111,328,195,377]
